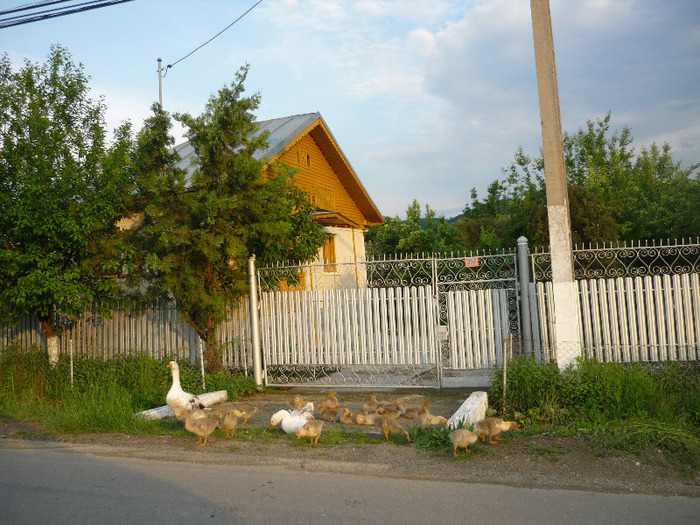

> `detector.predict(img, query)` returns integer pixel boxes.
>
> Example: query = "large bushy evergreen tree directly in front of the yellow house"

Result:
[129,66,326,372]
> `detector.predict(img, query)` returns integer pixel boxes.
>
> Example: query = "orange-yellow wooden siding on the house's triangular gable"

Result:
[280,134,366,226]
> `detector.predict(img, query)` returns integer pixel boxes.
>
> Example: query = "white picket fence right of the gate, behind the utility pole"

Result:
[531,274,700,363]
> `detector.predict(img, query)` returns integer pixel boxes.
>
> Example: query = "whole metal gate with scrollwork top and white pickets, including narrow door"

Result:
[258,253,519,388]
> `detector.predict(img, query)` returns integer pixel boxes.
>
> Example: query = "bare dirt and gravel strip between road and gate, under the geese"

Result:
[0,390,700,497]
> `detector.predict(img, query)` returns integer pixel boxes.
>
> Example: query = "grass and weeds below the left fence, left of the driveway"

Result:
[0,345,257,426]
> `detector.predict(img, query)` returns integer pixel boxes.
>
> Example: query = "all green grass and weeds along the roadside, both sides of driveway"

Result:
[0,346,700,471]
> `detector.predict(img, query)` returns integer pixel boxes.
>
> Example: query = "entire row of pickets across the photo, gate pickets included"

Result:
[0,247,700,384]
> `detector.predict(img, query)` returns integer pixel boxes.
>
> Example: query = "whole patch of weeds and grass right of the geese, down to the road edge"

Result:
[489,357,700,468]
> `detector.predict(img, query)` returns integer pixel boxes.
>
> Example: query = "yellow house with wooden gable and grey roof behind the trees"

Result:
[175,113,384,288]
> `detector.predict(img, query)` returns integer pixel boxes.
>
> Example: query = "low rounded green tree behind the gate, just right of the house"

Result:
[365,199,460,256]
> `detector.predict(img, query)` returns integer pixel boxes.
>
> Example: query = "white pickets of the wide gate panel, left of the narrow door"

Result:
[260,286,436,366]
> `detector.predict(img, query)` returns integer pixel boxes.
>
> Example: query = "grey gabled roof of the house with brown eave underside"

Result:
[175,113,384,226]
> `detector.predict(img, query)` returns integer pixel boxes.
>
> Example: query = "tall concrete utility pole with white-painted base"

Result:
[530,0,581,368]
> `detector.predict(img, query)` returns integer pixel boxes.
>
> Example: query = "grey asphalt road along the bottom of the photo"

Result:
[0,447,700,525]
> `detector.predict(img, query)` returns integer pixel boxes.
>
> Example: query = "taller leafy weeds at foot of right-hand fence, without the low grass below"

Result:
[489,357,700,425]
